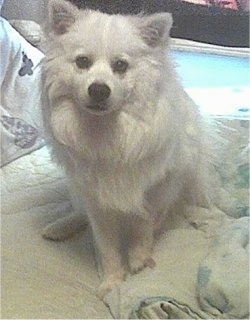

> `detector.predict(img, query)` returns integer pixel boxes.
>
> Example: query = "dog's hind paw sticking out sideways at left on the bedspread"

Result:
[42,215,88,241]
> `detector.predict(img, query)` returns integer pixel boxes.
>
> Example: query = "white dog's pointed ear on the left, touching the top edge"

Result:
[48,0,79,34]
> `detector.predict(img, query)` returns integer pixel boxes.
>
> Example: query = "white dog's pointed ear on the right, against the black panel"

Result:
[139,13,173,47]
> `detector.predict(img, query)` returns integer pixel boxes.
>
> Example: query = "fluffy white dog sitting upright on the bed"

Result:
[41,0,217,297]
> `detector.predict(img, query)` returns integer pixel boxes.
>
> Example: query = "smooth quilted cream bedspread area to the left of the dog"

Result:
[1,147,111,319]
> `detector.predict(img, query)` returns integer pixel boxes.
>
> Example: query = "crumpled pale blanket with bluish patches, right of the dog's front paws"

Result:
[106,207,249,319]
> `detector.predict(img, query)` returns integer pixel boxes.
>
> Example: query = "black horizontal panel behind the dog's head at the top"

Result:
[71,0,249,47]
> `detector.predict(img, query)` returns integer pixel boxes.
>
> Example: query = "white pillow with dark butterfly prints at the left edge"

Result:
[0,17,44,166]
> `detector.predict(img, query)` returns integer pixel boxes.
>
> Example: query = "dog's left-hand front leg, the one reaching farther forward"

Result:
[89,209,125,299]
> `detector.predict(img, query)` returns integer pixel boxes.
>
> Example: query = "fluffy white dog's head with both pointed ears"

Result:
[47,0,172,115]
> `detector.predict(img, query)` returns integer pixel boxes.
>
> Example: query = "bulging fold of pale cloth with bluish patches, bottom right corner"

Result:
[197,217,249,319]
